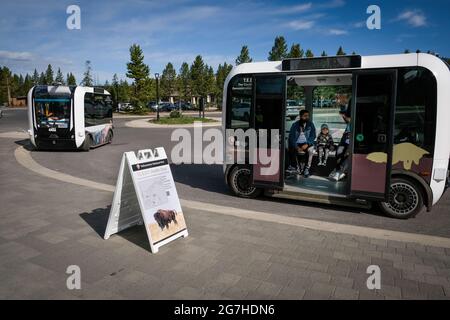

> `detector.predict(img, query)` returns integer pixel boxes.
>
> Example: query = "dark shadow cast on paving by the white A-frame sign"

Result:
[80,206,150,251]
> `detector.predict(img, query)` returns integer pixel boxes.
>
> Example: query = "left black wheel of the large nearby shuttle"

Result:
[228,166,262,198]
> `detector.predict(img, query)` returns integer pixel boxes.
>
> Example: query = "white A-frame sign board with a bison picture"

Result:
[104,148,188,253]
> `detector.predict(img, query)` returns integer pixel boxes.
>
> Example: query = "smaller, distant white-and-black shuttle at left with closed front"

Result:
[28,86,113,151]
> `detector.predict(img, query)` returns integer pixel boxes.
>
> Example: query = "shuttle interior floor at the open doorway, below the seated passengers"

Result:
[285,175,348,196]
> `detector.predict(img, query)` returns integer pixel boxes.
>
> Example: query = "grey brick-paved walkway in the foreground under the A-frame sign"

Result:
[0,191,450,299]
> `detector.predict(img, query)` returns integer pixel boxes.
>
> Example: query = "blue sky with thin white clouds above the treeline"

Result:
[0,0,450,82]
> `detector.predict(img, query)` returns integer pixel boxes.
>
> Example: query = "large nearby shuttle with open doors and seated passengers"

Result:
[223,53,450,219]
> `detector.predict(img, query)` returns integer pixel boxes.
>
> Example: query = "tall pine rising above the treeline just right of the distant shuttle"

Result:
[126,44,150,98]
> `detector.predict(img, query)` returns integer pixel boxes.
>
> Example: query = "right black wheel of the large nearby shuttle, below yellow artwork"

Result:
[380,178,424,219]
